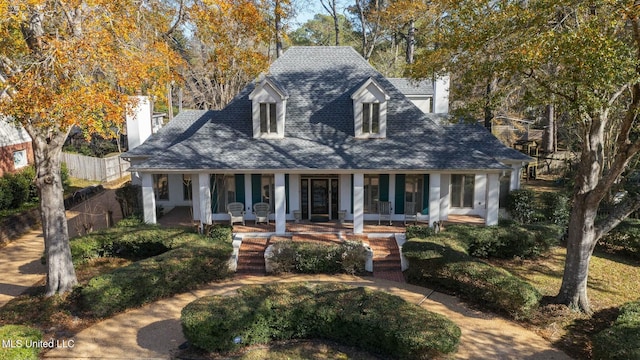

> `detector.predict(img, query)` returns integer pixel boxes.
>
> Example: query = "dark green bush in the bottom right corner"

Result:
[593,300,640,360]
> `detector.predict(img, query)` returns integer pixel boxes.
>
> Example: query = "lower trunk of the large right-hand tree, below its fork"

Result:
[556,194,598,313]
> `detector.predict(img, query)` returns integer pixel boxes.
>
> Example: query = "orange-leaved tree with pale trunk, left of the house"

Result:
[0,0,177,296]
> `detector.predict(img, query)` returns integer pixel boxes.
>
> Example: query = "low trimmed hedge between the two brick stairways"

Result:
[268,240,367,274]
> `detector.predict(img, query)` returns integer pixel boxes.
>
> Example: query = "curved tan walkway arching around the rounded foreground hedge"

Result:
[44,275,570,360]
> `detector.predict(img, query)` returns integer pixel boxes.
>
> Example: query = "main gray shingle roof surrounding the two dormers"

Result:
[125,47,506,171]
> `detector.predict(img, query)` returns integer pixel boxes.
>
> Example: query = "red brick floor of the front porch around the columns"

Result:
[158,206,485,234]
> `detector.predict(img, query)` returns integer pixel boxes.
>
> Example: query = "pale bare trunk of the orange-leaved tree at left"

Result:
[30,129,78,296]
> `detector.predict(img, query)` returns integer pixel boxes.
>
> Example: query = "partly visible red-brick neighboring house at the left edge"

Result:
[0,116,34,176]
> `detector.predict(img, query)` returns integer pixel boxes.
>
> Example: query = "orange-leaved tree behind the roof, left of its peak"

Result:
[181,0,273,109]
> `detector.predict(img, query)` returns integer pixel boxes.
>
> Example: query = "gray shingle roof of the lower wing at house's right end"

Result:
[445,123,533,161]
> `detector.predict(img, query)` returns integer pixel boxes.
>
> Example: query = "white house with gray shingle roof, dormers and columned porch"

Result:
[122,47,530,234]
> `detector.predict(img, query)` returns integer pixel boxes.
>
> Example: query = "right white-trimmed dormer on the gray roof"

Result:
[351,78,390,139]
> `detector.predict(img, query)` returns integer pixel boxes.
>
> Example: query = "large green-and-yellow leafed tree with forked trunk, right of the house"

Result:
[413,0,640,312]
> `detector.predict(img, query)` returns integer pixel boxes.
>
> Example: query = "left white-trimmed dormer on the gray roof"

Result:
[249,77,289,139]
